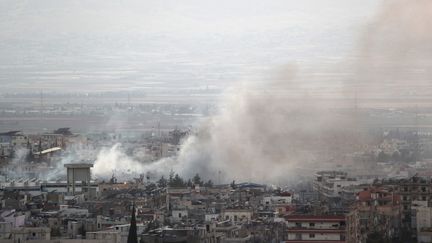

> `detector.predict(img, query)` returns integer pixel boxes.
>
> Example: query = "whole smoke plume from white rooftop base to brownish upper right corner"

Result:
[94,0,432,182]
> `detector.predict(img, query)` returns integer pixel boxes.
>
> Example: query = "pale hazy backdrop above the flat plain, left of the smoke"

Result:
[0,0,380,92]
